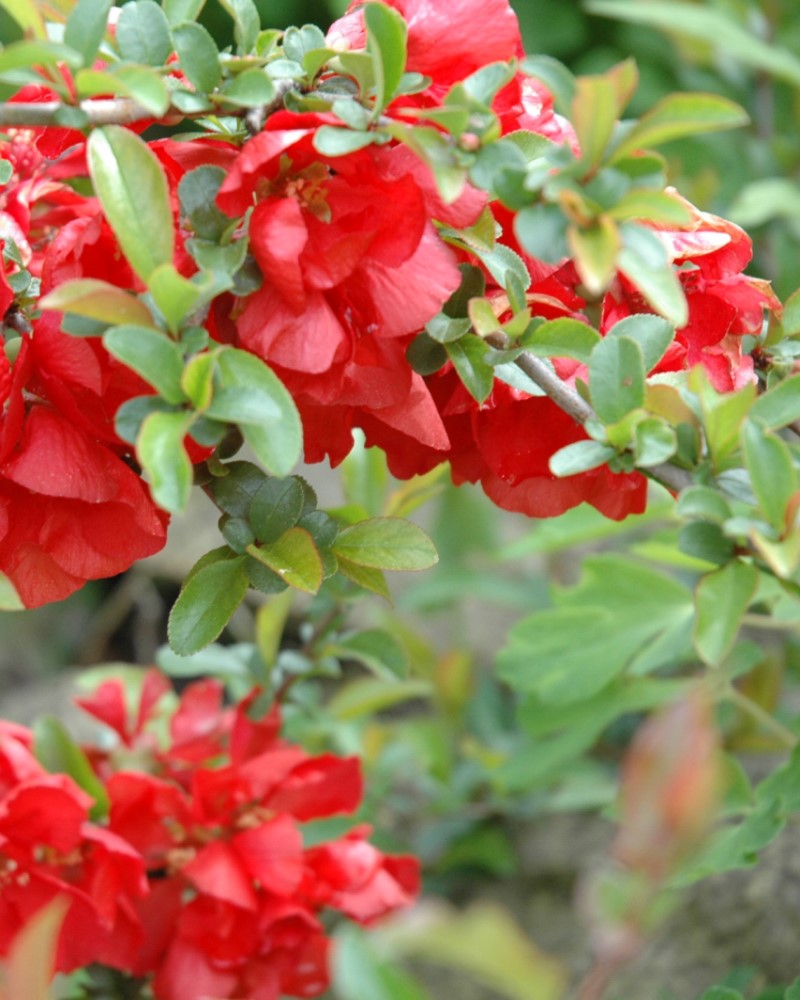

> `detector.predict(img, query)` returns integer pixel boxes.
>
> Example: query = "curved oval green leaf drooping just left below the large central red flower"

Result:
[211,348,303,477]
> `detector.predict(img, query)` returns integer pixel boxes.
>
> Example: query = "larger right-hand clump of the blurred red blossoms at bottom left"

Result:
[69,670,419,1000]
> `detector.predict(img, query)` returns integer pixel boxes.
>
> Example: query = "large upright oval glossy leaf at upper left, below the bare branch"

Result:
[87,128,175,282]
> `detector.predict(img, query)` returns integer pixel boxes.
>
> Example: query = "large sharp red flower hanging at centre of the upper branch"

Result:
[217,113,468,463]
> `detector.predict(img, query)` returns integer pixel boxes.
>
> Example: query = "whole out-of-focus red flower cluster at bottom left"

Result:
[0,670,419,1000]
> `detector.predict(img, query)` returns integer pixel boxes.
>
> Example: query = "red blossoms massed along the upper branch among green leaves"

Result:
[0,0,778,606]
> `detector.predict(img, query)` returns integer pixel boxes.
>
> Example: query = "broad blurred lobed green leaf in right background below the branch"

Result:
[497,555,694,705]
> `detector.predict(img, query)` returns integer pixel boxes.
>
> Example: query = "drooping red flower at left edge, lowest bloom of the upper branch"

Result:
[0,337,166,607]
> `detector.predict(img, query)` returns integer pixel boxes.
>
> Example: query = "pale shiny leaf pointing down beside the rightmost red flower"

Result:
[617,223,689,327]
